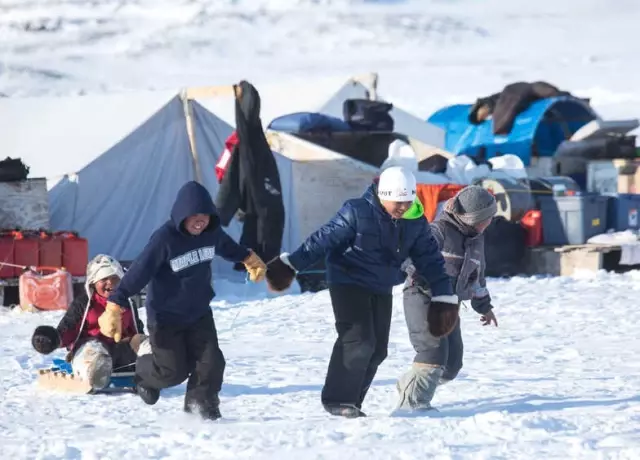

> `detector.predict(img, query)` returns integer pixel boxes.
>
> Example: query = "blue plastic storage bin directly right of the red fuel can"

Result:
[539,194,609,246]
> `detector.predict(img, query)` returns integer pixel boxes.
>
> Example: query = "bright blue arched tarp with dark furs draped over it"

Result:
[427,97,597,166]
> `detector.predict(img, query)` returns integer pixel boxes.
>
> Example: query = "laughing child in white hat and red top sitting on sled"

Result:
[31,254,146,390]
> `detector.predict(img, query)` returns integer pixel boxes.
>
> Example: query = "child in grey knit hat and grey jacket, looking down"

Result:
[397,186,498,410]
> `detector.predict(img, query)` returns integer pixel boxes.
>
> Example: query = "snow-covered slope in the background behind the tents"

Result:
[0,0,640,124]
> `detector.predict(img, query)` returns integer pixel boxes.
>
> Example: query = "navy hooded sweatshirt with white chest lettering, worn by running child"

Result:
[109,181,250,325]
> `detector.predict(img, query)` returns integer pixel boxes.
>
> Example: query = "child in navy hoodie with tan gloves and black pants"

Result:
[99,181,266,420]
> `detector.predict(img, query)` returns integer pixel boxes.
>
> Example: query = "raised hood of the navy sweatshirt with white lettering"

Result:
[171,181,220,235]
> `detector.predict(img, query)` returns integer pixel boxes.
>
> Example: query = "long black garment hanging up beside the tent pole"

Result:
[216,81,284,270]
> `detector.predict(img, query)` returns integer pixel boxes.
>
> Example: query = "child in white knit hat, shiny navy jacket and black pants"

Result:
[266,167,457,417]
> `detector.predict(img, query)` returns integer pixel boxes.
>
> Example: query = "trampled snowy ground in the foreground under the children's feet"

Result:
[0,272,640,460]
